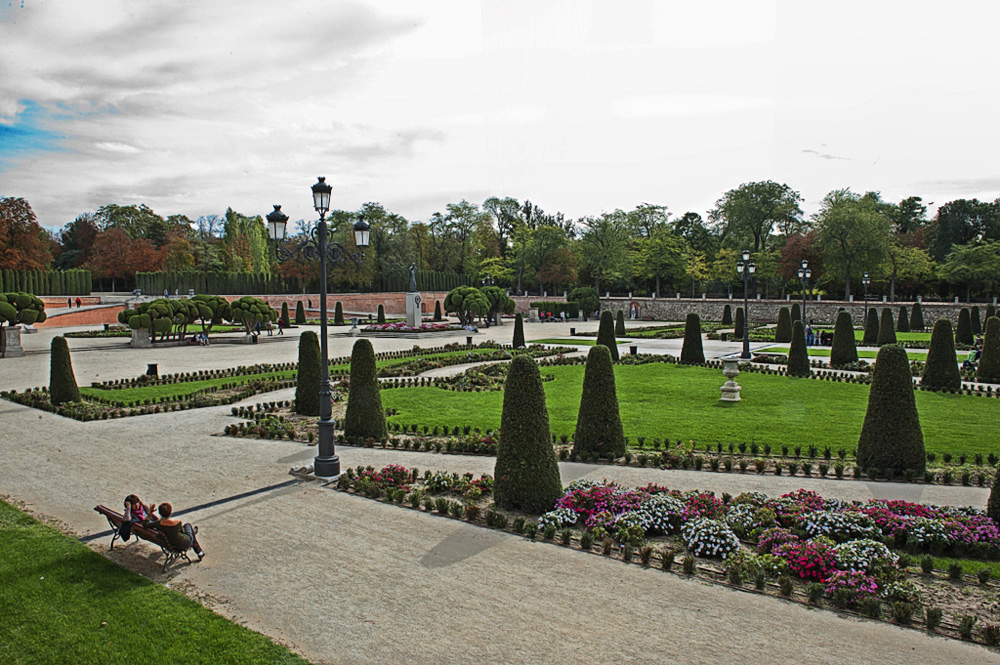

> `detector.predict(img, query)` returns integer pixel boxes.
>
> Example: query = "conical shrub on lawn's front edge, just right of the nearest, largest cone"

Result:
[573,344,620,459]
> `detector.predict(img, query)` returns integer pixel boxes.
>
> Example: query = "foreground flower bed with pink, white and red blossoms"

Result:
[336,465,1000,645]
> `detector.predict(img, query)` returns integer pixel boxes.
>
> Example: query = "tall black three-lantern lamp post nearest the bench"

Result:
[267,178,370,478]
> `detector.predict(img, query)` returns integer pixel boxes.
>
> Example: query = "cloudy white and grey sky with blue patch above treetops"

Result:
[0,0,1000,228]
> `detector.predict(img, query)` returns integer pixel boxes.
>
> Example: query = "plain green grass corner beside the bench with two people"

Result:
[0,501,306,665]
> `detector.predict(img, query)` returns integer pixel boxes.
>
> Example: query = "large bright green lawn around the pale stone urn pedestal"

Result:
[382,363,1000,455]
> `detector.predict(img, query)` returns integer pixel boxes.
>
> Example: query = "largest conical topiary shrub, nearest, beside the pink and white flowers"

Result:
[493,356,564,515]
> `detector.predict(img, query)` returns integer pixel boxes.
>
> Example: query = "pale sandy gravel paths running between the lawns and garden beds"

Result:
[0,321,1000,665]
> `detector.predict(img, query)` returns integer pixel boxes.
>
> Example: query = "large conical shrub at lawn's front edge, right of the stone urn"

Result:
[857,344,926,473]
